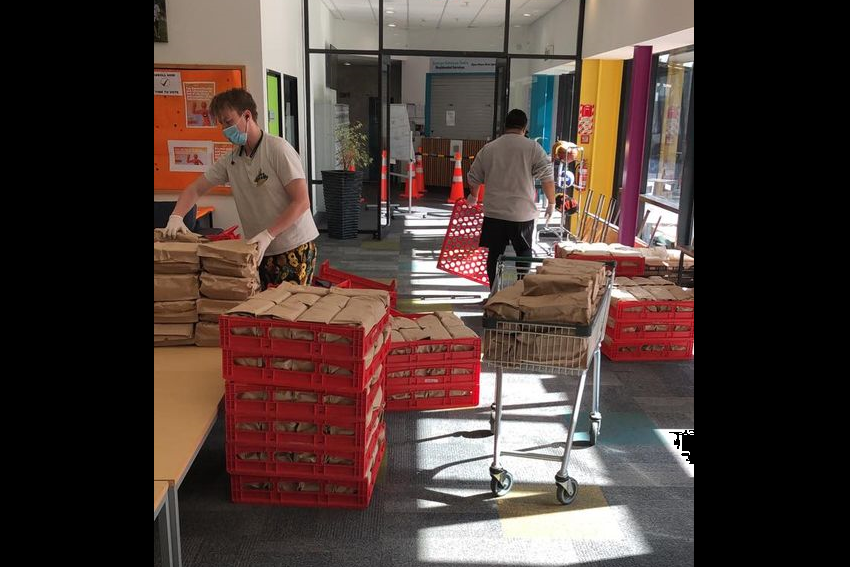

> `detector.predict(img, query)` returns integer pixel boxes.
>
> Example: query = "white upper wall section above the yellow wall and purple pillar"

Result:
[584,0,694,59]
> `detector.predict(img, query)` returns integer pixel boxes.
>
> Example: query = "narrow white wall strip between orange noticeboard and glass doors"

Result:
[260,0,307,173]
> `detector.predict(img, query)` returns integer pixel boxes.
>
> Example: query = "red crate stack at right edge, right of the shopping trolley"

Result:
[602,296,694,361]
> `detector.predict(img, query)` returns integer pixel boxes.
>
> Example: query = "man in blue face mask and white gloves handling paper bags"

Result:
[165,88,319,289]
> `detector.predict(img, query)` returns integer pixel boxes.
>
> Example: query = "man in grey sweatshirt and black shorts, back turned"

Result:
[467,108,555,287]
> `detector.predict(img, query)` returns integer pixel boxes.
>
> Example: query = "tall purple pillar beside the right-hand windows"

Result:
[619,45,652,246]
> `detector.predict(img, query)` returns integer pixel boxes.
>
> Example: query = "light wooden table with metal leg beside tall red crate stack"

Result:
[153,347,224,566]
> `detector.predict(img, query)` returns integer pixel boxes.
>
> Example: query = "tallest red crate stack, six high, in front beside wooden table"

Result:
[220,306,389,508]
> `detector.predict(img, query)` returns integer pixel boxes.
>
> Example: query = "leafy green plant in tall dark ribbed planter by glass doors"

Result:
[322,122,372,238]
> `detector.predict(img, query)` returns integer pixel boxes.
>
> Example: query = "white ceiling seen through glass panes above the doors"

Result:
[322,0,566,30]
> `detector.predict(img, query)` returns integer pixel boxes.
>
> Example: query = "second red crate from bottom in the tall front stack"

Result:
[226,423,386,481]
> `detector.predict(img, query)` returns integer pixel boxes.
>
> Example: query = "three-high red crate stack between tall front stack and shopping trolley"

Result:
[387,310,481,411]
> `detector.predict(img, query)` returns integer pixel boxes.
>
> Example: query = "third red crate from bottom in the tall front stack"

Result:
[225,406,386,450]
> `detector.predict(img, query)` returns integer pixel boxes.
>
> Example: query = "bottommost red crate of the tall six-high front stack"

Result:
[230,442,387,509]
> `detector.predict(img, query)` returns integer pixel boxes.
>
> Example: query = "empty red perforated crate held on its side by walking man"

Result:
[437,199,490,285]
